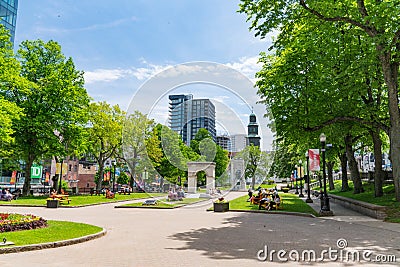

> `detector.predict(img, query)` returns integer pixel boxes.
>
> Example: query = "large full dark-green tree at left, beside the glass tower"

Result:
[6,40,89,195]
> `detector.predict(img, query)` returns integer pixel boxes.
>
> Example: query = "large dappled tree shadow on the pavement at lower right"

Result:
[169,213,400,265]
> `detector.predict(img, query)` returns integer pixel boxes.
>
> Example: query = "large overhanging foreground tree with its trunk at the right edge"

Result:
[240,0,400,201]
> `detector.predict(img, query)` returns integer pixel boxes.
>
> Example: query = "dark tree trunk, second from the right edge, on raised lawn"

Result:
[370,130,384,197]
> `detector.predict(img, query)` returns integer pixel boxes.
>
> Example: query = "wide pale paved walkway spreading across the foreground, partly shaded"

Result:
[0,192,400,267]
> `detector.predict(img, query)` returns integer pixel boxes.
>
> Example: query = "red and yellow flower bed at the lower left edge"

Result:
[0,213,47,233]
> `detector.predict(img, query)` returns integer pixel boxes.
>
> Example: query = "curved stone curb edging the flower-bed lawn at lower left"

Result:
[0,228,107,254]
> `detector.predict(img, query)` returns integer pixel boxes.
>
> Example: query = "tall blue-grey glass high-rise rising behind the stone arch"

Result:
[169,95,216,145]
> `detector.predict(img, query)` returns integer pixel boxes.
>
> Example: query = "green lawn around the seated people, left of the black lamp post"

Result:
[223,193,318,216]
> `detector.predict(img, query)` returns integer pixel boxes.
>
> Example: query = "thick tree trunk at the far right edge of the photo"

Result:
[377,51,400,201]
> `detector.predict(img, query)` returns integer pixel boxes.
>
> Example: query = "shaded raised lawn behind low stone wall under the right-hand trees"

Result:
[328,180,400,223]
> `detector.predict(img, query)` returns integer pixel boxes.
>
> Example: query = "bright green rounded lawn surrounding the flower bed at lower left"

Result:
[0,221,103,246]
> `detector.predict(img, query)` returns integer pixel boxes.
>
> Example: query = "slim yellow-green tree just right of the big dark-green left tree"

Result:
[86,102,125,193]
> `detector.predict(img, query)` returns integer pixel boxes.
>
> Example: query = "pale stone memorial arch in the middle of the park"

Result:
[187,161,215,194]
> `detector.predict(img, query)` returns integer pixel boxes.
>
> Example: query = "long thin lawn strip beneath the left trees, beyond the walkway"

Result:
[0,193,166,206]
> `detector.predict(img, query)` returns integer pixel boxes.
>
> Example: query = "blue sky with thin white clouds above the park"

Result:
[15,0,271,148]
